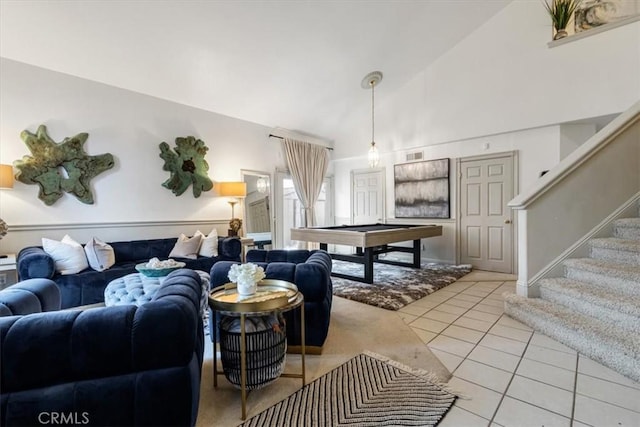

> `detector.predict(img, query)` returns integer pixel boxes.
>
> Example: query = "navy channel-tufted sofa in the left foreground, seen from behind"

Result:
[0,269,204,426]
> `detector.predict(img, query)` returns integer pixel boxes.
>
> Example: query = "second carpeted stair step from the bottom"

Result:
[540,278,640,333]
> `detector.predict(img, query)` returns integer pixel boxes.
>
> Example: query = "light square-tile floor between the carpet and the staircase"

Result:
[399,271,640,427]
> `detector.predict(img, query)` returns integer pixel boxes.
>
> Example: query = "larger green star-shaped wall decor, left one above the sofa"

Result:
[13,125,114,206]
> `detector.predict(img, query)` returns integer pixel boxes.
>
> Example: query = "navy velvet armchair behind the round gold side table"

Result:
[209,249,333,354]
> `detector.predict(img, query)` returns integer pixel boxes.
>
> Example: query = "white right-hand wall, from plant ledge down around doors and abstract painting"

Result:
[333,0,640,262]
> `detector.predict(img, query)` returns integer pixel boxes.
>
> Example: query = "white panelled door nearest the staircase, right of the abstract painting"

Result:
[460,153,514,273]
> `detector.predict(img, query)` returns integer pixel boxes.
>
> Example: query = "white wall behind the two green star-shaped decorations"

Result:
[0,58,284,252]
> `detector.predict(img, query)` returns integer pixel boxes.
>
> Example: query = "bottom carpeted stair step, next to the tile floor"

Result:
[503,293,640,381]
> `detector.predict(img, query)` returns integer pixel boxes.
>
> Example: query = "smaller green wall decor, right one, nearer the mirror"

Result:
[160,136,213,197]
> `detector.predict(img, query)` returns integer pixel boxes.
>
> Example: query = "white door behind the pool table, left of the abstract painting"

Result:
[351,169,385,224]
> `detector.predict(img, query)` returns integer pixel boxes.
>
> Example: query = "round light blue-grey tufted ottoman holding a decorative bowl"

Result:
[104,270,209,314]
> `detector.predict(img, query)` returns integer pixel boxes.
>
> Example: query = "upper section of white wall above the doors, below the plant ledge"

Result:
[334,0,640,158]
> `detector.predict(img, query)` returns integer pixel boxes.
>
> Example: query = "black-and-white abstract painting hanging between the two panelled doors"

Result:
[393,159,450,218]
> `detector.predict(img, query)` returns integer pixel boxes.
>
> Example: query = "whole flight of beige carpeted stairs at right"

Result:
[505,212,640,381]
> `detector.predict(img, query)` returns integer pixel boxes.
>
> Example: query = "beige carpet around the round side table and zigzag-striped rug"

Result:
[196,297,451,427]
